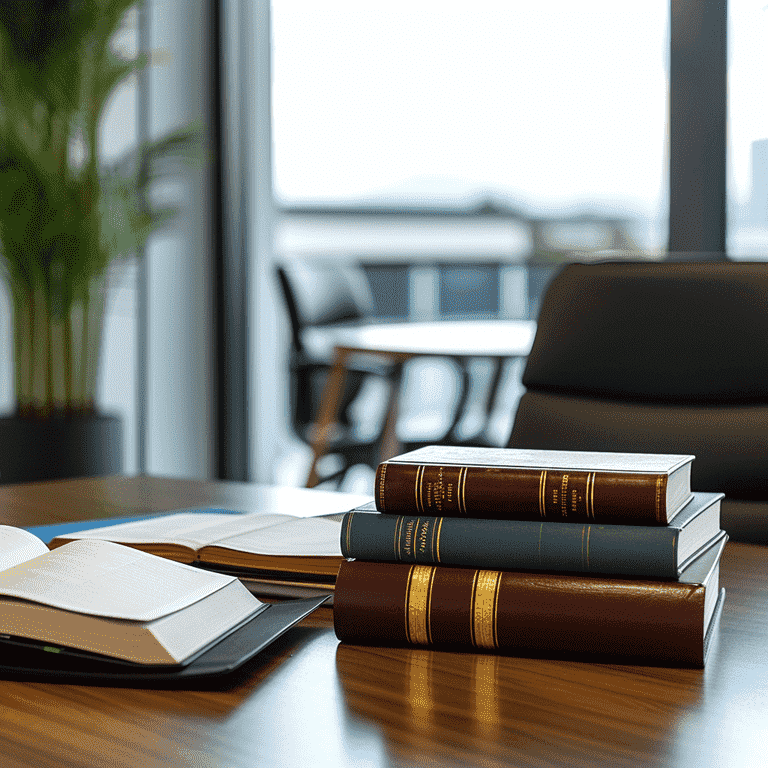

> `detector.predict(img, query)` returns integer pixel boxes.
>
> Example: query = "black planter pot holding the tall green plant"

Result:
[0,416,123,485]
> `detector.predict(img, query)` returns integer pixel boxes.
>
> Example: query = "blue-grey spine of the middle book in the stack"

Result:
[341,512,679,579]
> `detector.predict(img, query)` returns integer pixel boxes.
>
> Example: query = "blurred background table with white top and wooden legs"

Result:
[306,320,536,488]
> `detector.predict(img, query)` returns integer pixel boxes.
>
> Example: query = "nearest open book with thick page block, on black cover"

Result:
[0,525,268,665]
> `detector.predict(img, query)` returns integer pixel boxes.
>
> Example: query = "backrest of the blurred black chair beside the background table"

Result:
[276,260,374,351]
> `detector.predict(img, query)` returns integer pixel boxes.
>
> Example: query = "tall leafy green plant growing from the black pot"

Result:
[0,0,200,417]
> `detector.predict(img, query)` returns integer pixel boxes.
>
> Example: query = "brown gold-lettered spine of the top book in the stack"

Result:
[375,462,667,525]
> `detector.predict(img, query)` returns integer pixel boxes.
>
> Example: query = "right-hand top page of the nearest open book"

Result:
[0,539,240,621]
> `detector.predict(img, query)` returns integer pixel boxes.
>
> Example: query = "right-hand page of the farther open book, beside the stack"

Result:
[210,515,343,557]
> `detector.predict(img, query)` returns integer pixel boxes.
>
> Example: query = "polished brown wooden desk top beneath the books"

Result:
[0,477,768,768]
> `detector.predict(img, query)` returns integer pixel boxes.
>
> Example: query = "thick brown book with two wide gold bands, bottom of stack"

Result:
[333,539,726,667]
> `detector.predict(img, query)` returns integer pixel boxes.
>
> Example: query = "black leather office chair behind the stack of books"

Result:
[509,263,768,544]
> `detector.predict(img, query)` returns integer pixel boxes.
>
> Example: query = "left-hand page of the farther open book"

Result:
[61,512,296,550]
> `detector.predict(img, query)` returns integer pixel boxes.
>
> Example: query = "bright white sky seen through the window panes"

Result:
[272,0,768,222]
